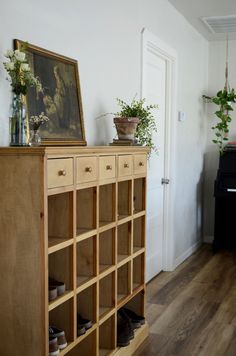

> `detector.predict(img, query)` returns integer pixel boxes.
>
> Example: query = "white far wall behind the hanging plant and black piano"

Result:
[204,40,236,242]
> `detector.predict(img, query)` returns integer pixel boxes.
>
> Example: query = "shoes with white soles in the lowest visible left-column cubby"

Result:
[49,326,67,356]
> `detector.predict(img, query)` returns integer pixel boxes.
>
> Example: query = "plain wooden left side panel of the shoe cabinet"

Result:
[0,155,46,356]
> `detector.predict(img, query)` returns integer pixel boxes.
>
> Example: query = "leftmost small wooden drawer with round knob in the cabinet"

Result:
[47,158,73,188]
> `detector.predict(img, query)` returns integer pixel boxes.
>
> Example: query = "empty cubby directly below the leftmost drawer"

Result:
[48,192,73,247]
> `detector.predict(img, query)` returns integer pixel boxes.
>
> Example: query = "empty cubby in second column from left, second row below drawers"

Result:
[76,235,97,286]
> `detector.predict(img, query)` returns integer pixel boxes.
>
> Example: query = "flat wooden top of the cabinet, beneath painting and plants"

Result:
[0,146,149,156]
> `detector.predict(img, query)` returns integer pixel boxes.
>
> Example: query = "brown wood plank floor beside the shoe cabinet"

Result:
[135,245,236,356]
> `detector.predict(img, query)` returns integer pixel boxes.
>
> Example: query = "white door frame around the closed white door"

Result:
[141,28,177,271]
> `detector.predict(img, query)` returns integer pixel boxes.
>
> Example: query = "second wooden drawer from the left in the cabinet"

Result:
[76,157,97,183]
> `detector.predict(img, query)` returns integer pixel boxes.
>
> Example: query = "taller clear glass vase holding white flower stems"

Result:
[9,94,28,146]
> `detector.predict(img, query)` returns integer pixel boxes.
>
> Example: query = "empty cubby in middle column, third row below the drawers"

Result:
[99,272,115,319]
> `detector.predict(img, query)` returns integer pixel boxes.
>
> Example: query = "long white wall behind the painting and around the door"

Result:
[0,0,208,268]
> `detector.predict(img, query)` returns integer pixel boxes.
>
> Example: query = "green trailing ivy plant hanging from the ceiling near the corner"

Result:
[203,88,236,154]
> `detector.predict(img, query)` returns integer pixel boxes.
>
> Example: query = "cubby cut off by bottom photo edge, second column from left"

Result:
[66,330,97,356]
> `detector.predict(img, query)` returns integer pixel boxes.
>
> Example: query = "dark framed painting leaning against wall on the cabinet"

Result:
[14,40,86,145]
